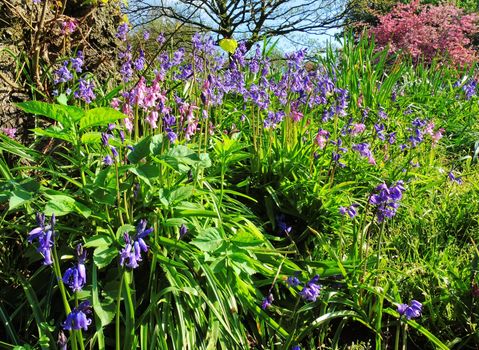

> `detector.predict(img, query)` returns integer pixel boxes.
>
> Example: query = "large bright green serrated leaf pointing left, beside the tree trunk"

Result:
[17,101,84,129]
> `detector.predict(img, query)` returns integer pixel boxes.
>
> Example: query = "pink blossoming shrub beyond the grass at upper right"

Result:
[371,0,479,66]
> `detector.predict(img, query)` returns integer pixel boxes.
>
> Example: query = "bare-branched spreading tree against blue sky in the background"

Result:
[126,0,349,48]
